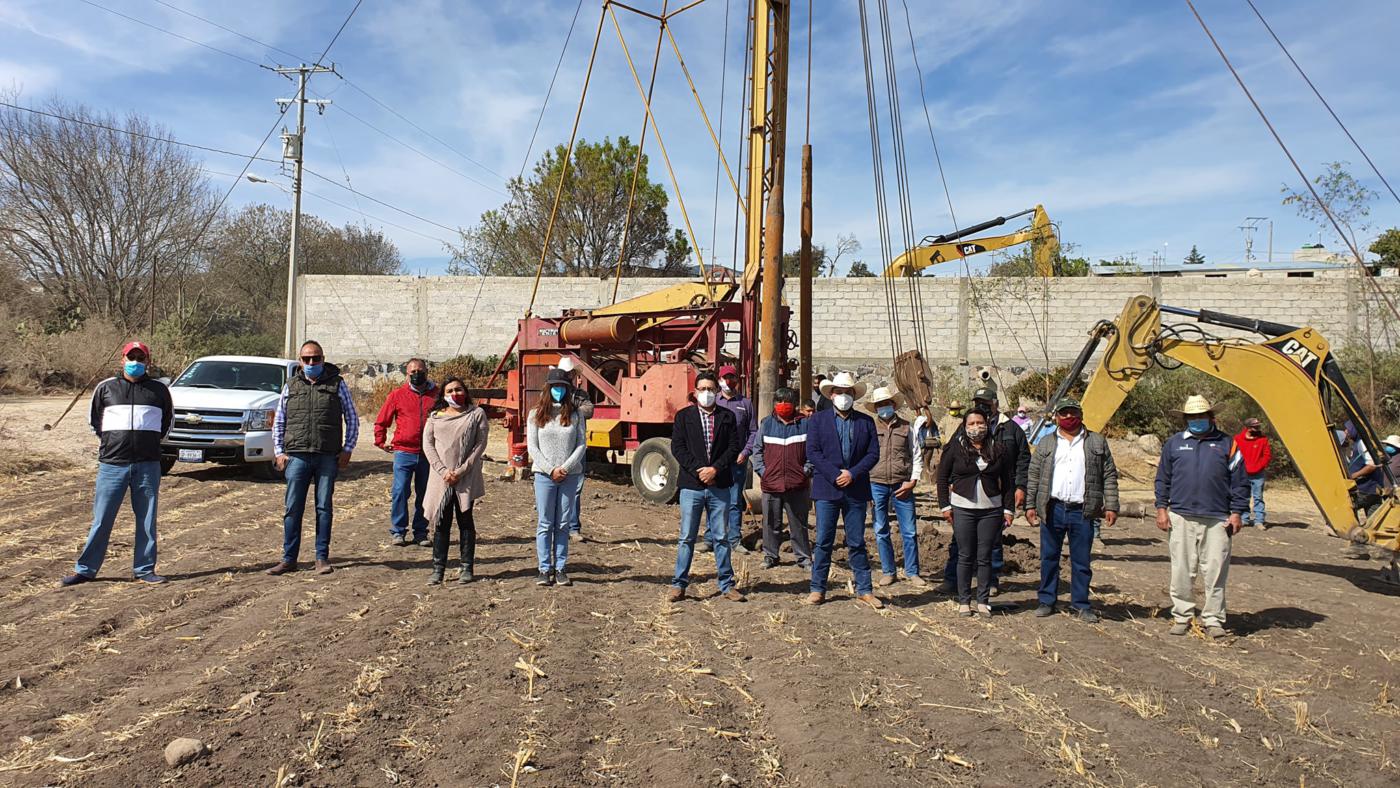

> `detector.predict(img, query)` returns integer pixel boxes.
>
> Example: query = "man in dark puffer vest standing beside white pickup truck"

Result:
[267,340,360,575]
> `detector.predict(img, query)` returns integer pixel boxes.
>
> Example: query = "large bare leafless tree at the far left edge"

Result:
[0,94,216,329]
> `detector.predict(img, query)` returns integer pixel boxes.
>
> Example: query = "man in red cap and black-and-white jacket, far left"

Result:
[63,342,175,586]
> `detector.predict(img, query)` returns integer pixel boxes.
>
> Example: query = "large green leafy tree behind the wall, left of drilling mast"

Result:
[448,137,690,277]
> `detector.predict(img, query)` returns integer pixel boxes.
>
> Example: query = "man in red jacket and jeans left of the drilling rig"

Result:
[374,358,438,547]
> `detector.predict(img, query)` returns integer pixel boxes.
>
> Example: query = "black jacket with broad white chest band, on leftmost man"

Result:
[88,377,175,465]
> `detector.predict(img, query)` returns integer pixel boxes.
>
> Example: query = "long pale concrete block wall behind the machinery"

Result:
[298,276,1400,371]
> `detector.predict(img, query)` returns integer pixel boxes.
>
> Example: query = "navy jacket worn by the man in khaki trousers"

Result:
[1156,430,1249,519]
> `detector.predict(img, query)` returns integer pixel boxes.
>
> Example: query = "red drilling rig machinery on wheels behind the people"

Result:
[480,275,792,502]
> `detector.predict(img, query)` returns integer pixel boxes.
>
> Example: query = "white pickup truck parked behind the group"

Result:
[161,356,297,479]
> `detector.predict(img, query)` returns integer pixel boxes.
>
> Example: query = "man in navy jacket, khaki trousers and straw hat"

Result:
[1156,395,1249,638]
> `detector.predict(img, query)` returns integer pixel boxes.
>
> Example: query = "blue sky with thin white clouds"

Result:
[0,0,1400,273]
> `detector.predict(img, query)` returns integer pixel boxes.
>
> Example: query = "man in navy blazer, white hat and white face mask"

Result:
[806,372,885,609]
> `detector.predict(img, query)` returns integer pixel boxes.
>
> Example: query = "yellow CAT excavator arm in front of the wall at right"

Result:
[1030,295,1400,551]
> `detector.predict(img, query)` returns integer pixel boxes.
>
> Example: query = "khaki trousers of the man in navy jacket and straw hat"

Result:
[1168,511,1231,627]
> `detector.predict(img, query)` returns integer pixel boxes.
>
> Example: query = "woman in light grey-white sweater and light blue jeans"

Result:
[526,370,587,585]
